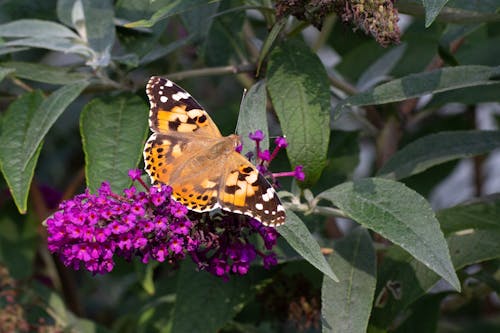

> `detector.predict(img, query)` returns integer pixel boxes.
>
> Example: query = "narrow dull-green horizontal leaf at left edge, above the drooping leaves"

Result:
[0,62,89,85]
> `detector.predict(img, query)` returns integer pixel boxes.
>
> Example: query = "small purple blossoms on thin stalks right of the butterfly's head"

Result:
[247,130,305,181]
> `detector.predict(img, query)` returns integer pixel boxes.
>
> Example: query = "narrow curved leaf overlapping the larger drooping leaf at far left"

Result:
[22,81,88,168]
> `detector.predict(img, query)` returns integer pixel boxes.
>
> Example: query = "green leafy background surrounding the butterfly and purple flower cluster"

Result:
[0,0,500,332]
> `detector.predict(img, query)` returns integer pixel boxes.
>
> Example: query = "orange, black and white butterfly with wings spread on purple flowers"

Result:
[144,76,286,227]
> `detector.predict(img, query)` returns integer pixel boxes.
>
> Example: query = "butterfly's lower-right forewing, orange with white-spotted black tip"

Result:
[219,152,286,227]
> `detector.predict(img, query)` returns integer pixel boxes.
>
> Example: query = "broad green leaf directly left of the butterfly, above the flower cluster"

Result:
[80,95,149,192]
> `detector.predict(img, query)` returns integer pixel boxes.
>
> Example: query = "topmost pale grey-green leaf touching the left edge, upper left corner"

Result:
[0,19,79,39]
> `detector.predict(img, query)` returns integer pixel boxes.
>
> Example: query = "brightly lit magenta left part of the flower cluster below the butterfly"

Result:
[46,183,193,273]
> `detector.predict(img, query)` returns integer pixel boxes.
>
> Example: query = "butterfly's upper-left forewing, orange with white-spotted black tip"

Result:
[146,76,222,137]
